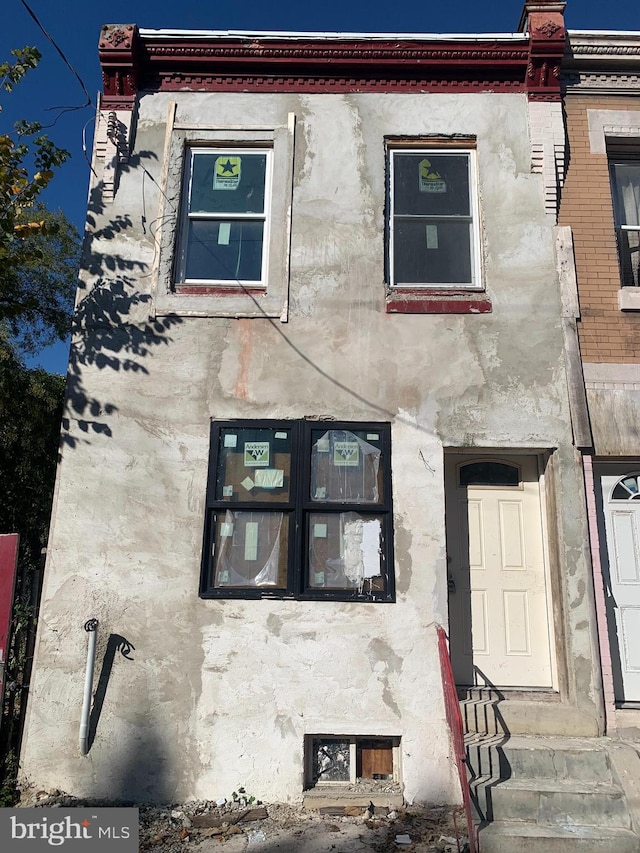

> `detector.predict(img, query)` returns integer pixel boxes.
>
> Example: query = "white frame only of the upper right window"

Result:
[387,144,483,291]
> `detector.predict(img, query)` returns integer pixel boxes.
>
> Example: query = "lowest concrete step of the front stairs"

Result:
[480,821,640,853]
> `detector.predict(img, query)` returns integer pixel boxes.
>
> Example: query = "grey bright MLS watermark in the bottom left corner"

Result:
[0,806,138,853]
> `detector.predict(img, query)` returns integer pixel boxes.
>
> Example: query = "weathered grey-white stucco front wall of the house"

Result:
[22,6,602,802]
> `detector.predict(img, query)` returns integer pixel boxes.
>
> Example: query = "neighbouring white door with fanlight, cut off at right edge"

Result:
[600,465,640,703]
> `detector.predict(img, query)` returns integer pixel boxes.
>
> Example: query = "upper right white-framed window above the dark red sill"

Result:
[389,148,480,288]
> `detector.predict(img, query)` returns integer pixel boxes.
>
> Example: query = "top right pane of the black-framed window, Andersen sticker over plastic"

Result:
[310,429,384,503]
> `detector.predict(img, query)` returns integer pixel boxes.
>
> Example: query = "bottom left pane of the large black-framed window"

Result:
[213,510,289,589]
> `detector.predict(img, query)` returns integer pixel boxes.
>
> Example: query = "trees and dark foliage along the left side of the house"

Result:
[0,47,80,806]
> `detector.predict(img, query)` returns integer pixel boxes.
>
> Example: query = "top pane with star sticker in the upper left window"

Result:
[189,150,267,213]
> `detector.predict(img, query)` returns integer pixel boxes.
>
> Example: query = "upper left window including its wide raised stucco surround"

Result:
[153,116,295,322]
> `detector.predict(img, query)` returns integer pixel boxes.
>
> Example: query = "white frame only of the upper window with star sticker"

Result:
[175,145,273,289]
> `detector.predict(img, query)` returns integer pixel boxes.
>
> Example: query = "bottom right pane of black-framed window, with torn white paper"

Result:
[308,512,384,592]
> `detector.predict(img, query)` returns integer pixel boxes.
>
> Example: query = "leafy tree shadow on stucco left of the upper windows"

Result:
[62,151,182,447]
